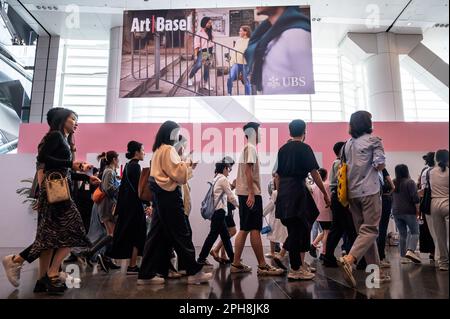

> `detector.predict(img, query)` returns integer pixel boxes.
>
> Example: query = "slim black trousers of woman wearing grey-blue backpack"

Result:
[198,209,234,261]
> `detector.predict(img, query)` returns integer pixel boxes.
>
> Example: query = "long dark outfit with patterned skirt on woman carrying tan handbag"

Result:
[30,131,91,258]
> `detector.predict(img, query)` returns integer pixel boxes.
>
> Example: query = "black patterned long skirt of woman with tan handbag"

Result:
[30,170,91,258]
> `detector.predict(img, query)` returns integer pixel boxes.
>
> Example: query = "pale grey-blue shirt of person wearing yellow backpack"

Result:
[344,134,386,198]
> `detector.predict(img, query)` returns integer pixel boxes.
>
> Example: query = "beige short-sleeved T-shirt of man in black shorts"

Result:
[236,143,261,196]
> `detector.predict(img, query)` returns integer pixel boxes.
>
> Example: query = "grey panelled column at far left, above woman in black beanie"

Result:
[30,36,60,123]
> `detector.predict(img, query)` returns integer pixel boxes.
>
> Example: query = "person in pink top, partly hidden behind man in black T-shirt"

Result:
[310,168,332,259]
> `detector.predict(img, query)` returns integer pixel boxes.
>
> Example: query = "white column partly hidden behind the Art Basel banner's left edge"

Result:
[105,27,131,123]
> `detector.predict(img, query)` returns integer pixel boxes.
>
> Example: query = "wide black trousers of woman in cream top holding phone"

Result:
[139,180,202,279]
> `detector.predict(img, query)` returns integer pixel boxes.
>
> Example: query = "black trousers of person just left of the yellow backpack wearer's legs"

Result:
[325,192,356,262]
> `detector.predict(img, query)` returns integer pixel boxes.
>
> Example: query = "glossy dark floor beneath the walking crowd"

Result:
[0,247,449,299]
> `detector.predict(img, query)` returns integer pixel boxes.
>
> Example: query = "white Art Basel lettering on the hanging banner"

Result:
[131,15,191,33]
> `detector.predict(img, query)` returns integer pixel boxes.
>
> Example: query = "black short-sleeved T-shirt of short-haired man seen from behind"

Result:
[275,141,319,179]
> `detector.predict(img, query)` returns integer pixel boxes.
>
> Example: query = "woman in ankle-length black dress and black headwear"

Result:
[108,141,147,275]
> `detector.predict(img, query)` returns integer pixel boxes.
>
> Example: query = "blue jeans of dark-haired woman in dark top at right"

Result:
[394,214,419,257]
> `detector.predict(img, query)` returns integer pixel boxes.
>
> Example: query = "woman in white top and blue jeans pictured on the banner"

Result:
[227,25,252,95]
